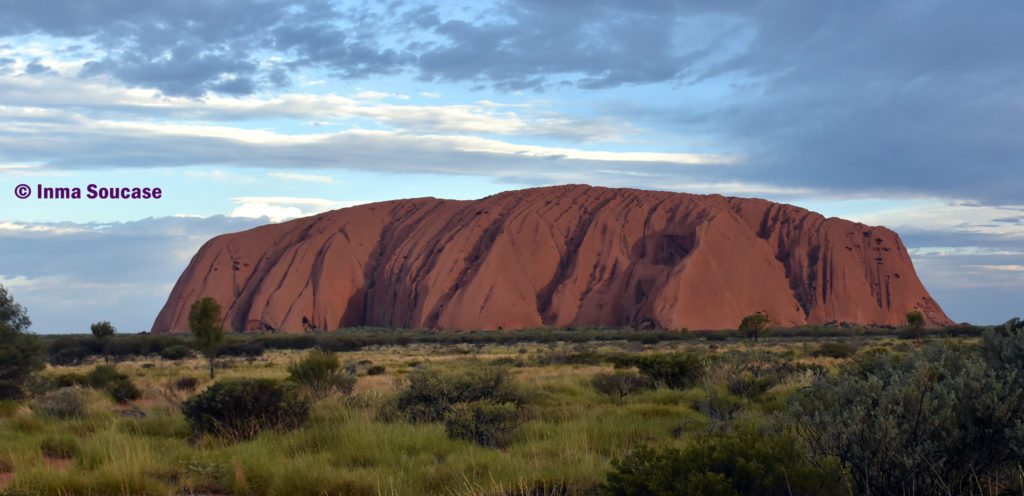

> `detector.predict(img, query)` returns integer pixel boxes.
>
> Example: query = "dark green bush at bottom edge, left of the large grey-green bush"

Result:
[601,425,843,496]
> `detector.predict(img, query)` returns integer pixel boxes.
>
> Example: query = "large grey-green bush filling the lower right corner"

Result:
[793,332,1024,494]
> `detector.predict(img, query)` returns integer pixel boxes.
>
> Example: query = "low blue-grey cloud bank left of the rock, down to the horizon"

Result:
[0,216,263,332]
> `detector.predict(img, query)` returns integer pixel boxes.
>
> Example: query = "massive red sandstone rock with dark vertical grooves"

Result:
[153,185,951,332]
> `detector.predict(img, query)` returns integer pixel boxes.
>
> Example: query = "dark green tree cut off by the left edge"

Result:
[0,286,43,400]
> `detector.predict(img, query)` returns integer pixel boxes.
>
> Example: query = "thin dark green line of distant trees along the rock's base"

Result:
[41,325,989,365]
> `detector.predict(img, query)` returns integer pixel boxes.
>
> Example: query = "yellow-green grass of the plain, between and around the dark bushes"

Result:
[0,332,1011,495]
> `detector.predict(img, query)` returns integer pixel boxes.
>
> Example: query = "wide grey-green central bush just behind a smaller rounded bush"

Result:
[396,367,522,422]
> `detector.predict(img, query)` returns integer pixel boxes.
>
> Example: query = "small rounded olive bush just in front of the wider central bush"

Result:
[444,400,519,448]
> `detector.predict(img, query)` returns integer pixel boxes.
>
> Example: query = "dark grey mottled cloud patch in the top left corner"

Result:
[0,0,403,96]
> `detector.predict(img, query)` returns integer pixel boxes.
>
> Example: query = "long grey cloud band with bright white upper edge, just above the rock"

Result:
[0,95,737,188]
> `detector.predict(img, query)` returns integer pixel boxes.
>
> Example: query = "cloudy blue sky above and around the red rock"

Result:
[0,0,1024,333]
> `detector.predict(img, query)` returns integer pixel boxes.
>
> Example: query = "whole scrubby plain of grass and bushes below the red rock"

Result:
[0,284,1024,496]
